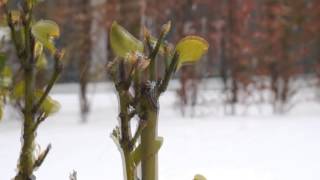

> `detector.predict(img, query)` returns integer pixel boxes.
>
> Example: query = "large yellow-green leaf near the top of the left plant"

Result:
[31,20,60,54]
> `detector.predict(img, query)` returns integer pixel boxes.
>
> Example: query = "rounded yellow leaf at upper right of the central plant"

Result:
[176,36,209,66]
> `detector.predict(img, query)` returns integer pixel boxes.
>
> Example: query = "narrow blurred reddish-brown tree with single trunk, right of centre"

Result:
[220,0,254,114]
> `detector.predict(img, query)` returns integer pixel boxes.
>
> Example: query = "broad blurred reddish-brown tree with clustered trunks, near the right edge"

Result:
[256,0,310,113]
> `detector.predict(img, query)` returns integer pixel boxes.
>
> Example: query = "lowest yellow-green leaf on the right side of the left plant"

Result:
[35,90,61,116]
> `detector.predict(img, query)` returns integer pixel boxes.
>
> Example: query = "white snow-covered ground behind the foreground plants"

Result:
[0,83,320,180]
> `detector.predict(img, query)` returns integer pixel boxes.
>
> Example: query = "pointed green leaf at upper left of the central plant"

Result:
[110,22,143,58]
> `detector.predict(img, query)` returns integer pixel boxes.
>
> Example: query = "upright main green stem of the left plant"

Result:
[15,3,36,177]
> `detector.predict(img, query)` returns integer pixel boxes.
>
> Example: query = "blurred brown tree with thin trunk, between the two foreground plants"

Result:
[47,0,110,122]
